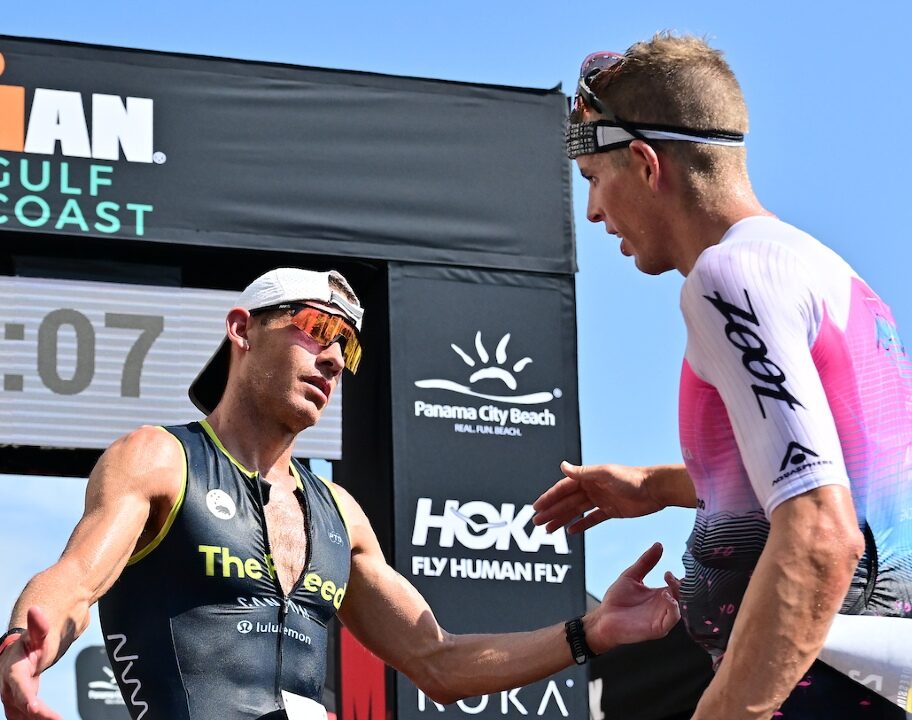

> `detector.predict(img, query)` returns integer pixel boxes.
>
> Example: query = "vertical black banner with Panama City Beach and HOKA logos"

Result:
[390,265,588,720]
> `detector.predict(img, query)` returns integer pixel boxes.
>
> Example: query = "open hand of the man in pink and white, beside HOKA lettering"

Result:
[532,461,662,534]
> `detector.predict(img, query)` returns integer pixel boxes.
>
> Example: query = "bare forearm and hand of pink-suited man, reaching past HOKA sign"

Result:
[532,461,697,534]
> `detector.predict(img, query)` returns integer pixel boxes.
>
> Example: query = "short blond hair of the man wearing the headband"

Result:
[586,32,748,195]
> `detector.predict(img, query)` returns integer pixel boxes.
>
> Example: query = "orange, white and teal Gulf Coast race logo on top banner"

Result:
[0,53,159,237]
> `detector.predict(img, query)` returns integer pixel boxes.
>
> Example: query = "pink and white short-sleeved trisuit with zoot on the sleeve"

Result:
[679,217,912,656]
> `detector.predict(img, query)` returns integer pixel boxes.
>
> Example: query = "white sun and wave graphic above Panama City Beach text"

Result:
[415,330,561,405]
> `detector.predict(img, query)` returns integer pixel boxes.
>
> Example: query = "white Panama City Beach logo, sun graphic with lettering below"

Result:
[415,330,562,437]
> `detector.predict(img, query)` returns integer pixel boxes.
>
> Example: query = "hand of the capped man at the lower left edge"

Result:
[0,607,63,720]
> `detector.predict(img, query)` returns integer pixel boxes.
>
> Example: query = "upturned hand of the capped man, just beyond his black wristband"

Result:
[584,543,681,653]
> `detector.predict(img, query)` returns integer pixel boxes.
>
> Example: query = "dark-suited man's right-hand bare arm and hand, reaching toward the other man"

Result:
[339,484,679,703]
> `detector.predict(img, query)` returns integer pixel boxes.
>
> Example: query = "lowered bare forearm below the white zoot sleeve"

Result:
[694,488,864,720]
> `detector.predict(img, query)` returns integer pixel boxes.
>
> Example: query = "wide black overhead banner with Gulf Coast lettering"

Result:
[0,36,576,273]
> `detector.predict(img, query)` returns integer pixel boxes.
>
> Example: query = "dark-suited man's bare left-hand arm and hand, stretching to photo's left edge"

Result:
[0,427,183,720]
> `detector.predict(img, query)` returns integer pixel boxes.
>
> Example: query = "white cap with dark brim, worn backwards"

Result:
[187,268,364,415]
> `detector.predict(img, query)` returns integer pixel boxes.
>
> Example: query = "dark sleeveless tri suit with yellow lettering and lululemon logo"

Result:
[99,423,351,720]
